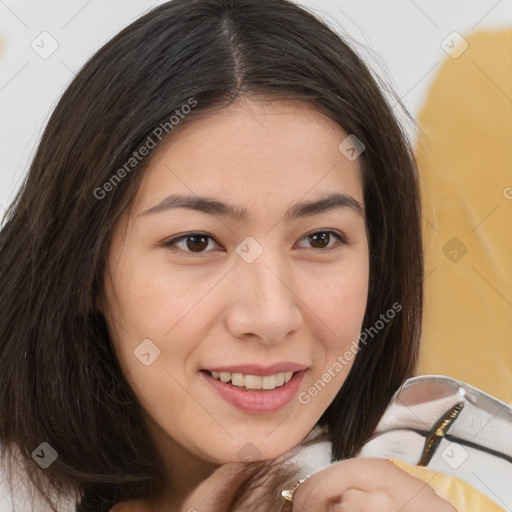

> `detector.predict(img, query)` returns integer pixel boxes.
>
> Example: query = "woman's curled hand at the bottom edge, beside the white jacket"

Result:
[292,458,457,512]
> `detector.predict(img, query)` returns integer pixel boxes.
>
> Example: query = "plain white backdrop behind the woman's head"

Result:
[0,0,512,512]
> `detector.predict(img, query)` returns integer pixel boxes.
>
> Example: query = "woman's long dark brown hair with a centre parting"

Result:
[0,0,423,512]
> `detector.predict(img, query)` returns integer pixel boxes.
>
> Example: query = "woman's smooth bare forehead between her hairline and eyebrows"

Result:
[134,99,363,213]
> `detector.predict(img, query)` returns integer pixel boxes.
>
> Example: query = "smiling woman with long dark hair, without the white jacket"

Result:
[0,0,455,512]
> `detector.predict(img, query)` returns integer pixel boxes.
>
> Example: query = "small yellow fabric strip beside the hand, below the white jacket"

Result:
[391,460,506,512]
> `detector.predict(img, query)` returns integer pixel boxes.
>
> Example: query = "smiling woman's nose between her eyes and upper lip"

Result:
[225,245,304,344]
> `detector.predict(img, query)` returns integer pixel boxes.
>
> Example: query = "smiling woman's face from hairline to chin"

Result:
[99,99,369,464]
